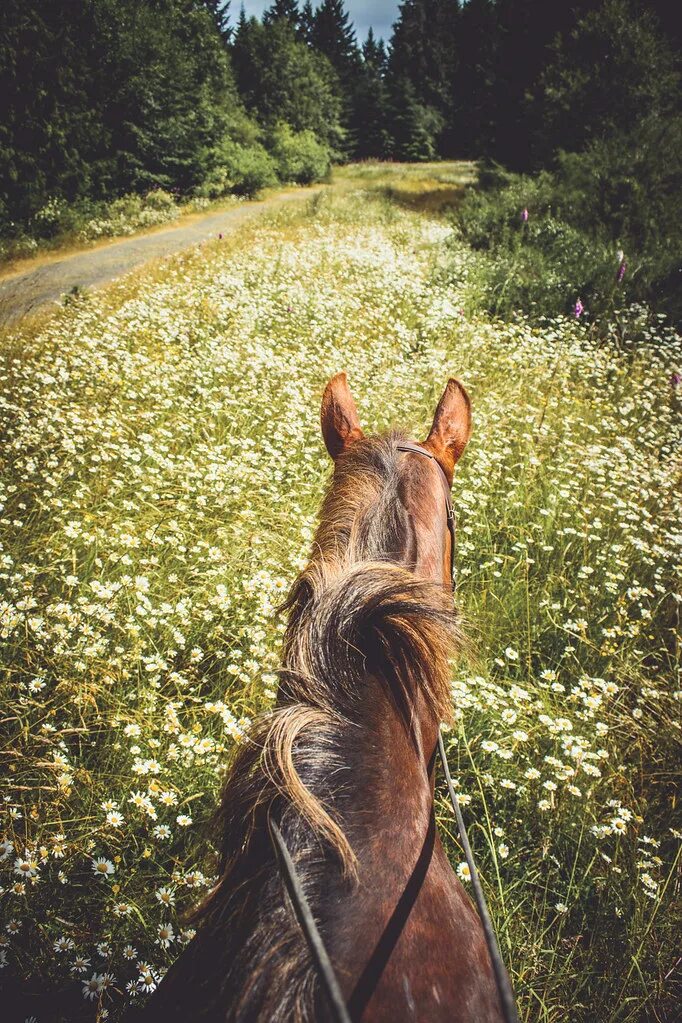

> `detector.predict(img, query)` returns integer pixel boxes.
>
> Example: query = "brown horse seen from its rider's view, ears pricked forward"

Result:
[139,372,503,1023]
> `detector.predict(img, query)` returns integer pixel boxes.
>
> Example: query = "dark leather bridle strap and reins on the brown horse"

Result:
[270,441,518,1023]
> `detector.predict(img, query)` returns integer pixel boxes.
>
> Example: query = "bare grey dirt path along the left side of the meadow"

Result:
[0,186,320,326]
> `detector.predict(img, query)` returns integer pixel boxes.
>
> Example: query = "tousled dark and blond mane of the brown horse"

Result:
[144,433,461,1023]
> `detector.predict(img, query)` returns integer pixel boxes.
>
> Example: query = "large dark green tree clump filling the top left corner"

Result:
[0,0,238,219]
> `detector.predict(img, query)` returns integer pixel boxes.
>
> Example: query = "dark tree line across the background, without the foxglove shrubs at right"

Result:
[0,0,680,248]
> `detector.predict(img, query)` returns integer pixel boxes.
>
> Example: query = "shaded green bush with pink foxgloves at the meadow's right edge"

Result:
[457,129,682,321]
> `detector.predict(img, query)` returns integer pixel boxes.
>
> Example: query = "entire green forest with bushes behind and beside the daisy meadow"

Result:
[0,0,682,318]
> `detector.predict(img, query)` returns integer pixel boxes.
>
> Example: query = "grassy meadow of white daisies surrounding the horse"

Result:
[0,165,682,1023]
